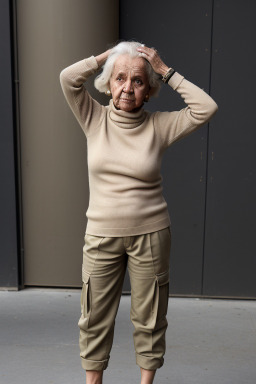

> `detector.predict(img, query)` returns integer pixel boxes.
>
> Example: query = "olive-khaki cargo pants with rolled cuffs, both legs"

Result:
[78,227,171,370]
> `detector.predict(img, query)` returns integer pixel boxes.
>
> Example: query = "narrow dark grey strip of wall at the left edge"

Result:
[0,0,19,288]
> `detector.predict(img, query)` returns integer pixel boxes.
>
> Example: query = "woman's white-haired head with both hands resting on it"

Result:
[94,41,168,112]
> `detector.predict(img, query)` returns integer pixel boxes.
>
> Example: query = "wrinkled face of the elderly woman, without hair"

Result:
[110,55,150,112]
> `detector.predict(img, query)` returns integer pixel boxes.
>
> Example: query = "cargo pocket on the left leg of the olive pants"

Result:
[78,266,91,331]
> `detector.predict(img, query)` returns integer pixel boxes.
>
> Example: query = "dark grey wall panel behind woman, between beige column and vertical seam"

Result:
[120,0,212,295]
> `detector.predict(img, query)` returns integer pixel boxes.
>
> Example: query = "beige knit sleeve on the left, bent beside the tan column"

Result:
[60,56,104,136]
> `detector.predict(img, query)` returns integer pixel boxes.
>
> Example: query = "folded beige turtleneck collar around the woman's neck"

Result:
[109,99,146,129]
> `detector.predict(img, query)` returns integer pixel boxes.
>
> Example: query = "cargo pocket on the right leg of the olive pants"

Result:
[152,270,169,328]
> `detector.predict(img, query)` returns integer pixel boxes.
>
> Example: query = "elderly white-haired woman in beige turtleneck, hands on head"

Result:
[60,42,217,384]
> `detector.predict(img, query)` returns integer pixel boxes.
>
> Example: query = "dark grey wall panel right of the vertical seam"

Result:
[203,0,256,297]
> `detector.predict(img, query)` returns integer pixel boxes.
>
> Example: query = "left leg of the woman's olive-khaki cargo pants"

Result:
[78,235,127,370]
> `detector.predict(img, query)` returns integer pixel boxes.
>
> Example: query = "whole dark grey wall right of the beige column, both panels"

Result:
[120,0,256,297]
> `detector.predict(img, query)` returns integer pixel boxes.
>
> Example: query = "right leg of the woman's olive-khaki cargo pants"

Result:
[126,228,171,370]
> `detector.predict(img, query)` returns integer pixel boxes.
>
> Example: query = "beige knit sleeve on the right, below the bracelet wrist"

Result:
[153,72,218,147]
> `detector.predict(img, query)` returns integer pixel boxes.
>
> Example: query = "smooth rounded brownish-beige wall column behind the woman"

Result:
[17,0,118,287]
